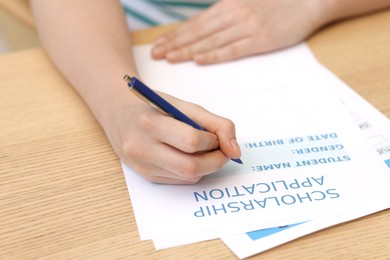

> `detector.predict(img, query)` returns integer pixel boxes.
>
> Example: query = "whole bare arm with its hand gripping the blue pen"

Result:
[31,0,240,183]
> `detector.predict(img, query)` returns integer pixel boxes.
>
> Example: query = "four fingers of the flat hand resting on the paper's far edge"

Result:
[152,13,261,64]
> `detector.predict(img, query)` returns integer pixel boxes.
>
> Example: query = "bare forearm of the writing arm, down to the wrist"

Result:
[31,0,137,123]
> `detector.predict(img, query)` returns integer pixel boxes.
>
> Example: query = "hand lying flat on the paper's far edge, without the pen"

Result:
[152,0,326,64]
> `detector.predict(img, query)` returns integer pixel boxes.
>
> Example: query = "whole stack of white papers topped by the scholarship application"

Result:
[123,44,390,258]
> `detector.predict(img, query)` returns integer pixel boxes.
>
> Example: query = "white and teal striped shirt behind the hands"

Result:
[120,0,216,31]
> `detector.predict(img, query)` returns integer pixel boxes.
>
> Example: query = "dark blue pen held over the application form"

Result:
[123,75,242,164]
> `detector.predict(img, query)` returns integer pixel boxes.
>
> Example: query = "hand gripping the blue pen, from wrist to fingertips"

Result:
[102,92,240,184]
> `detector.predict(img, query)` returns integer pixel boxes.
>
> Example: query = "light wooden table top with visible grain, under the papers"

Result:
[0,10,390,259]
